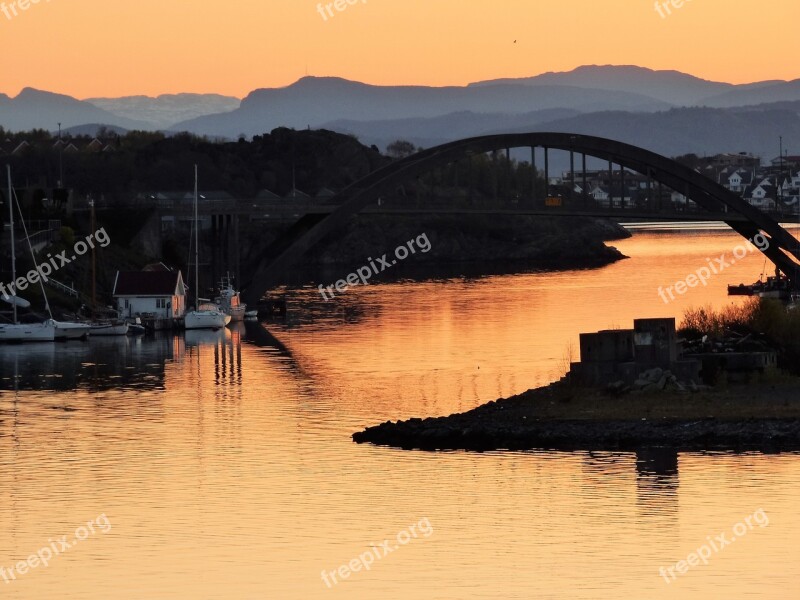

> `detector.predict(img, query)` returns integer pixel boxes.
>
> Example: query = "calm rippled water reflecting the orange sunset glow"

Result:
[0,227,800,600]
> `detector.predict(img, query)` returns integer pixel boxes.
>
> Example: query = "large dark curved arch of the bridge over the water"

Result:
[244,132,800,303]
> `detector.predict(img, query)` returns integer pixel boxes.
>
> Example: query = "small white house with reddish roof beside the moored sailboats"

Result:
[114,269,186,319]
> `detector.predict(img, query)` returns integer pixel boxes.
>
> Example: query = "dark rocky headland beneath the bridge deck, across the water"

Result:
[243,214,631,279]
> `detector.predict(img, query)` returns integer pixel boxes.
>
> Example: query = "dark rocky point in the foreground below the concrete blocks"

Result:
[353,382,800,452]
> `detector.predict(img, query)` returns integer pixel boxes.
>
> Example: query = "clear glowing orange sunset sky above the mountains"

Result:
[0,0,800,98]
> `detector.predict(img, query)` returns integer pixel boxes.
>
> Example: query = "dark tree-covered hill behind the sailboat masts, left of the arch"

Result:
[0,128,389,201]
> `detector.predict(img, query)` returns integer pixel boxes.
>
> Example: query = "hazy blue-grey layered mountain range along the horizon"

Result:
[0,66,800,157]
